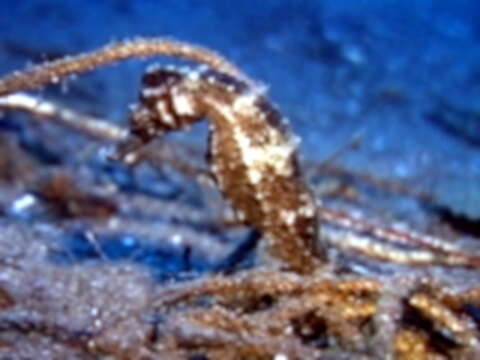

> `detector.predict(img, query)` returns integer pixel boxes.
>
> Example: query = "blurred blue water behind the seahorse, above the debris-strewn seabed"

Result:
[0,0,480,221]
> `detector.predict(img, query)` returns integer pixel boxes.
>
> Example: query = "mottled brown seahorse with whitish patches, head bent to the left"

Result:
[125,67,324,273]
